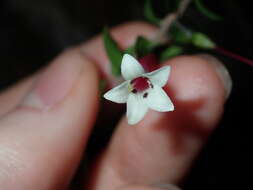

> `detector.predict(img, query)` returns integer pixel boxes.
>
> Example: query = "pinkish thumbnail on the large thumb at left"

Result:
[23,50,82,109]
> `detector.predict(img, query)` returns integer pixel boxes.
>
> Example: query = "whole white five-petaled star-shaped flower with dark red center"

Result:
[104,54,174,125]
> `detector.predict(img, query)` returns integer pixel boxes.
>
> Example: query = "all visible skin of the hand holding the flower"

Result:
[0,22,229,190]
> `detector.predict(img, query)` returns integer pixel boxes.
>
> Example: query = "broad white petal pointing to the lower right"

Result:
[145,85,174,112]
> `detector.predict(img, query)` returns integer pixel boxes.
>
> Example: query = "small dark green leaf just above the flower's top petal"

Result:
[135,36,157,57]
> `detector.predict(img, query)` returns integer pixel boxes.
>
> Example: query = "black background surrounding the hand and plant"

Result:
[0,0,253,190]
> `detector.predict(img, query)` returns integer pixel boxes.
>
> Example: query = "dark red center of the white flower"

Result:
[130,77,153,93]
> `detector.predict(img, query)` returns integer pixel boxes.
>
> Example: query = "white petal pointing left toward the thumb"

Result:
[104,81,130,103]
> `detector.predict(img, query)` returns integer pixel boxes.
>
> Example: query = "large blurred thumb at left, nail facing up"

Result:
[0,49,98,190]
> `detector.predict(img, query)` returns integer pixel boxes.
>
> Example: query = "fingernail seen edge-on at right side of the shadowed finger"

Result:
[198,54,232,99]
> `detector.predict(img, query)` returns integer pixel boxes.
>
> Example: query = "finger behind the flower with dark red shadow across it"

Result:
[87,56,231,189]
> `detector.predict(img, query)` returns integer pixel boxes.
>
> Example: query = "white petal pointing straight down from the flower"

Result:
[127,93,148,125]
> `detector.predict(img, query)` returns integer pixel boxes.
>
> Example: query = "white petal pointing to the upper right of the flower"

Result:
[143,66,170,87]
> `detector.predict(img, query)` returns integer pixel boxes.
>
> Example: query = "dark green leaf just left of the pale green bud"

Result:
[169,23,192,44]
